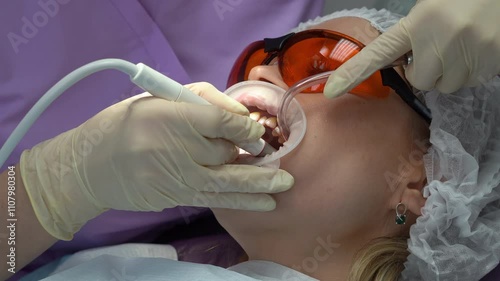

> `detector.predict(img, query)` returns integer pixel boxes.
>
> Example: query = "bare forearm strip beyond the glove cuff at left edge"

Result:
[0,166,57,280]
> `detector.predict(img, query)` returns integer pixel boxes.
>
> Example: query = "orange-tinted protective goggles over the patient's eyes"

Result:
[227,29,398,97]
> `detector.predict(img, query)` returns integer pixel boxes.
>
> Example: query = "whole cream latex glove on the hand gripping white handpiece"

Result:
[20,87,293,240]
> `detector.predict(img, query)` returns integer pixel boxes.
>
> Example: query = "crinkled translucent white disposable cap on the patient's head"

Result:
[293,8,500,280]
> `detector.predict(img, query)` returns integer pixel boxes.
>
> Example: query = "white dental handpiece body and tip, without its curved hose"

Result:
[130,63,276,156]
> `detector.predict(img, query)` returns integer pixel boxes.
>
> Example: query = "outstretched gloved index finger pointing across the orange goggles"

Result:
[324,22,411,98]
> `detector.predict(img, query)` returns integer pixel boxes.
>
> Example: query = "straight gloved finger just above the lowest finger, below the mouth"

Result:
[186,164,294,193]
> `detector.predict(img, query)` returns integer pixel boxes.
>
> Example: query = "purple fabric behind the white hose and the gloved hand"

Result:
[0,0,323,277]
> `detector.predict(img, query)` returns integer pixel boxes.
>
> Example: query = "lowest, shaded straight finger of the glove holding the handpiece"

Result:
[187,192,276,212]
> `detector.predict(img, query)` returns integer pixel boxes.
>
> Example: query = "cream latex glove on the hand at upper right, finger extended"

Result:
[324,0,500,98]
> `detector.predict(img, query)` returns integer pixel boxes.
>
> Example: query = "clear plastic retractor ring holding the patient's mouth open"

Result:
[225,81,307,168]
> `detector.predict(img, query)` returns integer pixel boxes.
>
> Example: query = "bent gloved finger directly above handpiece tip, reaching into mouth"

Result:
[185,104,265,144]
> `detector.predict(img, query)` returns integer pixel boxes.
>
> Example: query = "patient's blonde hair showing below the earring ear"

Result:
[347,237,409,281]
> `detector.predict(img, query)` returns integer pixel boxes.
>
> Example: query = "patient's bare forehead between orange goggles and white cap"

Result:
[308,17,380,45]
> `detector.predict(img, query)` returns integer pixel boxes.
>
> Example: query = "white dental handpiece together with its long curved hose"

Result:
[0,59,276,166]
